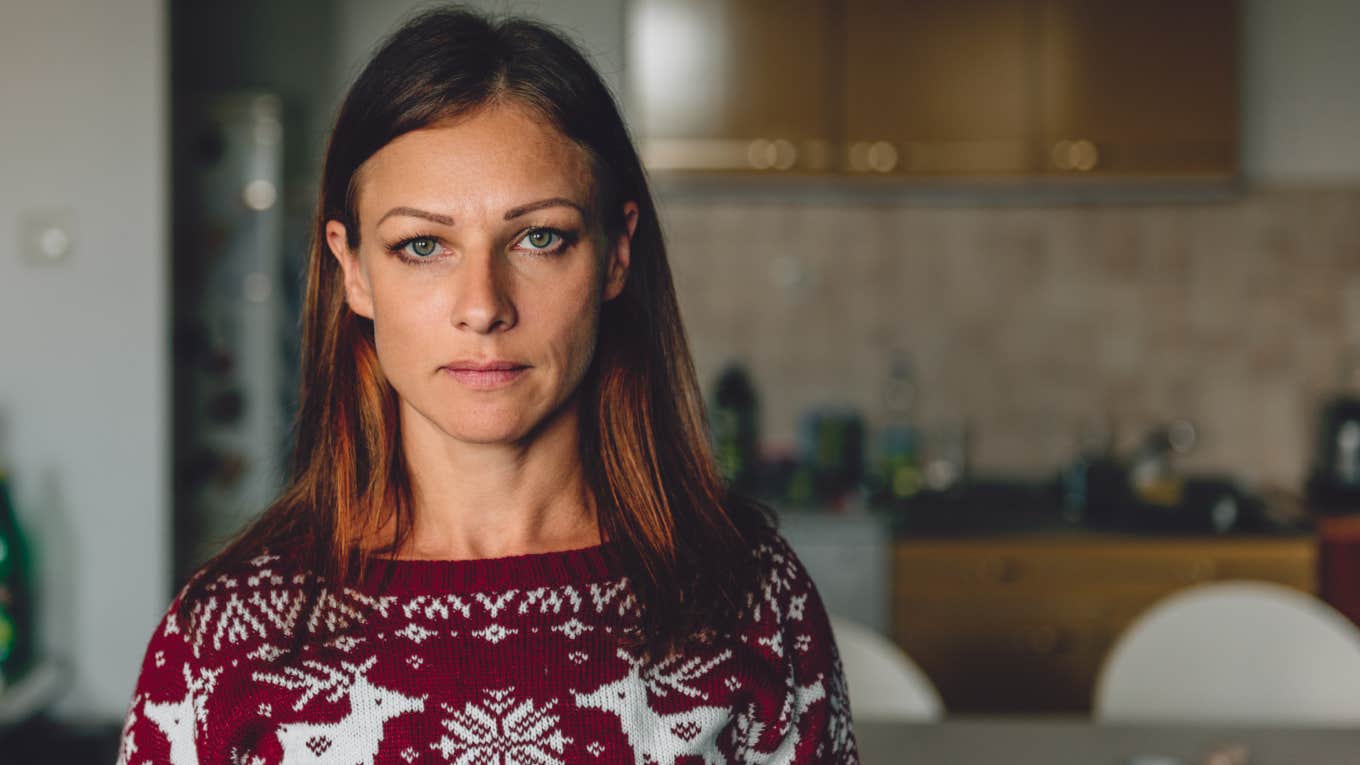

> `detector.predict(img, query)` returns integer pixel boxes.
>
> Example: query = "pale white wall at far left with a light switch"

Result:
[0,0,170,719]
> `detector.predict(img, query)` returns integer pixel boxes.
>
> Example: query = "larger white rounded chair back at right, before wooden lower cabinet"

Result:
[1095,581,1360,726]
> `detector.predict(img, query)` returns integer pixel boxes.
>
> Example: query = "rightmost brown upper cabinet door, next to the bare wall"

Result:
[1040,0,1239,176]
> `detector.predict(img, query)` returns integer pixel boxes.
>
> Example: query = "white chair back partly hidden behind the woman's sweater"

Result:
[831,617,944,723]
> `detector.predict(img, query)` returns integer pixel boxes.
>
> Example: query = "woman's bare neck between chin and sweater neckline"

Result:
[397,394,600,559]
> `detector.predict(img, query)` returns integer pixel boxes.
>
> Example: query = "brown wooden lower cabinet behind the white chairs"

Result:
[892,534,1318,715]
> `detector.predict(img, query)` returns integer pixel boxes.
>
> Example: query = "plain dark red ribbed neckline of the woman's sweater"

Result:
[364,544,623,595]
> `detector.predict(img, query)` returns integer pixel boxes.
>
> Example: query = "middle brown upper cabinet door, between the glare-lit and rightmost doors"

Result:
[843,0,1042,176]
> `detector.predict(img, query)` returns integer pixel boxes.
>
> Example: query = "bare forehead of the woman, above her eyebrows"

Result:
[355,105,593,219]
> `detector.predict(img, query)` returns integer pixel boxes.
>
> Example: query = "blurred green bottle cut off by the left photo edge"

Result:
[0,468,33,691]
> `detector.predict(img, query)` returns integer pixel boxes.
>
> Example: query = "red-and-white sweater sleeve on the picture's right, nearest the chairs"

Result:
[755,534,860,765]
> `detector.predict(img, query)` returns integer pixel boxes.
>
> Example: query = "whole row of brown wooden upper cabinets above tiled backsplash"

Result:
[630,0,1239,178]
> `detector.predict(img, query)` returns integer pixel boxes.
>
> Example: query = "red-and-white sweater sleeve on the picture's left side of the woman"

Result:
[117,599,211,765]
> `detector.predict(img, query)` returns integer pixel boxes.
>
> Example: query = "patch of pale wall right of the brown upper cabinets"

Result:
[1242,0,1360,184]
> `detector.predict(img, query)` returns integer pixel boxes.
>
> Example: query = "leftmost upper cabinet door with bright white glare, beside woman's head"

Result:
[628,0,836,172]
